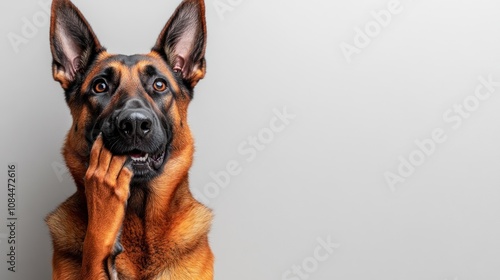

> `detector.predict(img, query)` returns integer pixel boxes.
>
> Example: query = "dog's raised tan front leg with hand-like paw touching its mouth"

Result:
[81,136,133,280]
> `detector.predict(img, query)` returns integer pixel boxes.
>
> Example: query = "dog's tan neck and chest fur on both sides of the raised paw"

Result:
[47,59,213,280]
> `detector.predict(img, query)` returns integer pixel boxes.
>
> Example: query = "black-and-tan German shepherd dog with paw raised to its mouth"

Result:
[46,0,213,280]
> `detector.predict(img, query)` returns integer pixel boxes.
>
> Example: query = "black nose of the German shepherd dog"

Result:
[117,109,153,138]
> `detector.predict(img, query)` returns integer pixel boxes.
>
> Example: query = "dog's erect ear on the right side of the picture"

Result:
[153,0,207,88]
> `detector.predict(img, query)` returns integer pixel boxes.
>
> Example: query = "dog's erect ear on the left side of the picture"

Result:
[50,0,103,89]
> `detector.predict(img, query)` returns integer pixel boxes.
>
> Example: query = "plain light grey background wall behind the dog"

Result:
[0,0,500,280]
